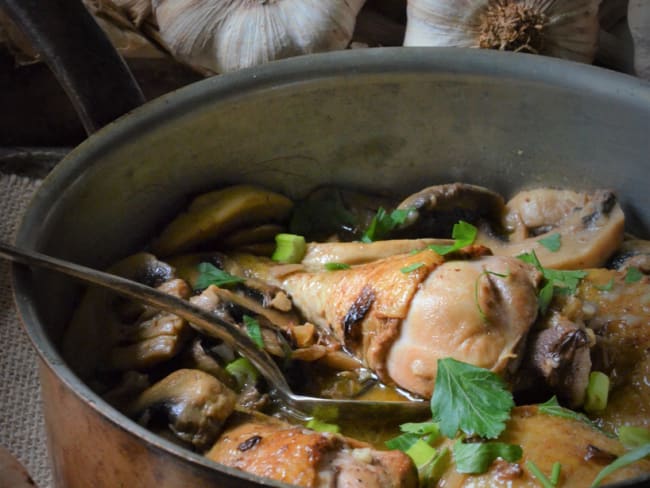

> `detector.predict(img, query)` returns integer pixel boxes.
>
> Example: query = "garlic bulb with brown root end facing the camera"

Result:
[404,0,600,63]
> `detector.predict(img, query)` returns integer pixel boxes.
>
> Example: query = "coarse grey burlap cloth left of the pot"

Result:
[0,173,52,488]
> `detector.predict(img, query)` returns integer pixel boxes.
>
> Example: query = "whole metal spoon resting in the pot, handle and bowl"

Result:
[0,241,430,422]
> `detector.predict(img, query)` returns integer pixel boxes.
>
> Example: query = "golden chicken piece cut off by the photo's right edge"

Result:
[560,269,650,432]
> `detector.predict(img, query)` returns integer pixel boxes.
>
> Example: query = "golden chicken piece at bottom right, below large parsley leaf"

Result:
[438,406,650,488]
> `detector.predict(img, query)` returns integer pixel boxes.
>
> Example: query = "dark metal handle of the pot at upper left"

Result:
[0,0,145,134]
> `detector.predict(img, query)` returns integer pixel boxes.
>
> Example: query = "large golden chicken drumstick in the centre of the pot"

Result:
[230,247,540,396]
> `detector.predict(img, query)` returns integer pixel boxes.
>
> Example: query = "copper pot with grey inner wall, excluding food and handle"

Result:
[5,2,650,488]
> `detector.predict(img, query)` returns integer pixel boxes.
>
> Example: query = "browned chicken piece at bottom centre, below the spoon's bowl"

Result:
[206,412,417,488]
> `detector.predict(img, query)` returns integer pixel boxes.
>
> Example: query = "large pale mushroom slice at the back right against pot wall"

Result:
[477,188,625,269]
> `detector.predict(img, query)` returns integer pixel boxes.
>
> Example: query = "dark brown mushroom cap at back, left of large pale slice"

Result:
[393,183,504,237]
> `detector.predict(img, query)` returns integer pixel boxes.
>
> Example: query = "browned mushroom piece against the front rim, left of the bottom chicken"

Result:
[126,369,237,450]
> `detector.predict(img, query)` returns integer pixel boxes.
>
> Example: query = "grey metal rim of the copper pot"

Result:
[12,47,650,486]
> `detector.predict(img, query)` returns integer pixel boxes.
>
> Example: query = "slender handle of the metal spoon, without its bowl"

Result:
[0,241,291,396]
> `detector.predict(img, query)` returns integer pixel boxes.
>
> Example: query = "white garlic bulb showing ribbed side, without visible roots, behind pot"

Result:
[153,0,365,73]
